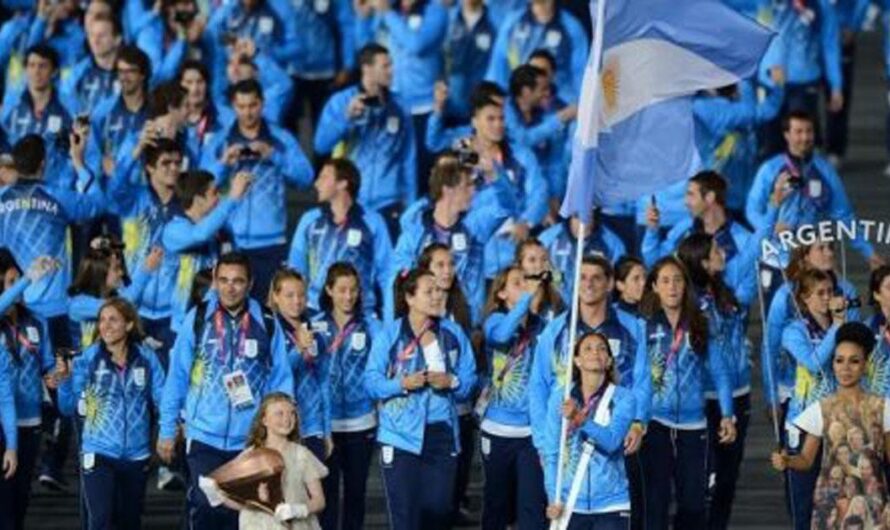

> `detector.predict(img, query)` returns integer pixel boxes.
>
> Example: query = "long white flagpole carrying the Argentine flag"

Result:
[550,0,606,530]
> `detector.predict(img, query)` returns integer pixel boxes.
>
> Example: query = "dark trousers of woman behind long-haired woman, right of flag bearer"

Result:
[706,394,751,530]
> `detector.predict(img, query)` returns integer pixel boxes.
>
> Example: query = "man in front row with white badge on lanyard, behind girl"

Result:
[157,253,294,530]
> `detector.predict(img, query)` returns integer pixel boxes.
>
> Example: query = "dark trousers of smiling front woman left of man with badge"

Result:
[81,453,148,530]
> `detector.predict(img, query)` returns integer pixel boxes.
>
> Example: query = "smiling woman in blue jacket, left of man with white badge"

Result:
[59,298,164,530]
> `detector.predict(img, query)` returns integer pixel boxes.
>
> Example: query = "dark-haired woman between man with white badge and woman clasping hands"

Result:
[312,261,380,530]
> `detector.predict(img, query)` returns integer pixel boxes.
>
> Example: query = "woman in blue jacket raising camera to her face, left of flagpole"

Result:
[476,265,547,530]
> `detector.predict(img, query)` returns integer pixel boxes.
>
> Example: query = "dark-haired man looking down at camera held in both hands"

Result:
[201,79,312,299]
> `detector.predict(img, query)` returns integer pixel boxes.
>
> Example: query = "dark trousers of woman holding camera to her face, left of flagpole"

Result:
[479,432,547,530]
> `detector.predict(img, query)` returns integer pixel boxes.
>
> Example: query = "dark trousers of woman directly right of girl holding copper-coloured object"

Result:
[321,429,375,530]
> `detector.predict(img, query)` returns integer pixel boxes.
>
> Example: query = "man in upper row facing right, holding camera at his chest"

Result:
[315,44,417,237]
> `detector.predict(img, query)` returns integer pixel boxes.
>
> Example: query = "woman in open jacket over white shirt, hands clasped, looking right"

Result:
[364,269,476,530]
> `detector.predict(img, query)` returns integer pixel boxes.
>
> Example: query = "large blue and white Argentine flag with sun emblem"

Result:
[560,0,772,221]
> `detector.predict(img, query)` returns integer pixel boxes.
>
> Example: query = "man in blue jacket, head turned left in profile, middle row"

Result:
[287,158,392,312]
